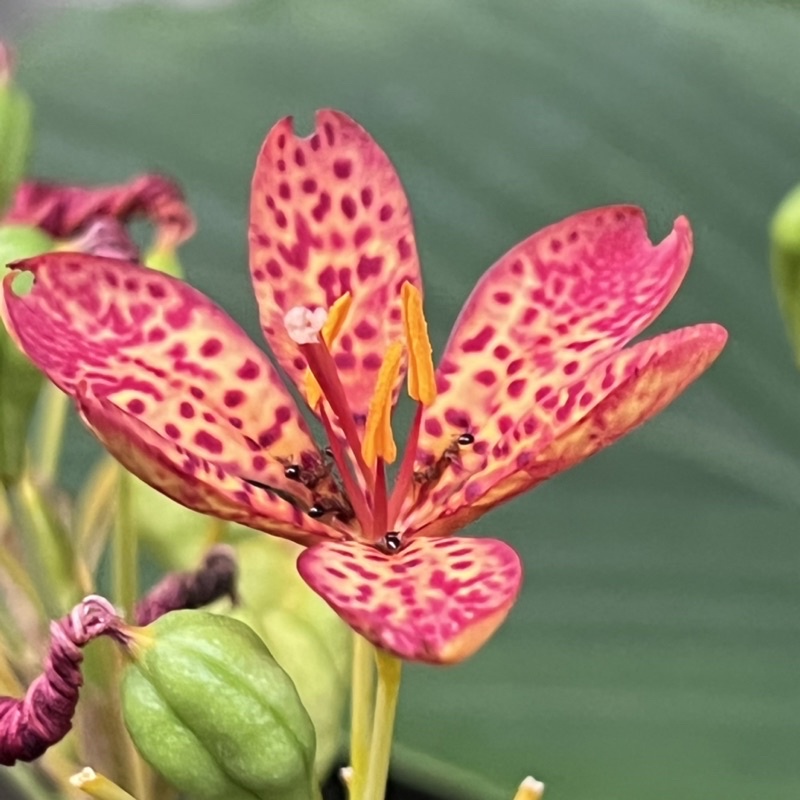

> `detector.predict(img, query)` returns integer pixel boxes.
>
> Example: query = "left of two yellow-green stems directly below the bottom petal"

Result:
[349,632,375,800]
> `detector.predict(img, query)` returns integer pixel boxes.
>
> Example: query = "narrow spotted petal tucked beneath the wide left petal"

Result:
[76,386,342,544]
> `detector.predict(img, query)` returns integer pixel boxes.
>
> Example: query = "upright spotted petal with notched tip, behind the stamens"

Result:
[250,110,420,425]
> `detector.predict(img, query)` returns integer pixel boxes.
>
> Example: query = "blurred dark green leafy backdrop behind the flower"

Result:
[10,0,800,800]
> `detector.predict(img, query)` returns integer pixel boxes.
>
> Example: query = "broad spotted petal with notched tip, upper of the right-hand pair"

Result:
[419,206,692,467]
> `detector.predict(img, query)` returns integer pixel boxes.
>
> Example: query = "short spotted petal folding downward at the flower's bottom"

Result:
[297,538,522,664]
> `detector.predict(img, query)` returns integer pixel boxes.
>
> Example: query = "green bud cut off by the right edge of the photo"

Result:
[770,186,800,367]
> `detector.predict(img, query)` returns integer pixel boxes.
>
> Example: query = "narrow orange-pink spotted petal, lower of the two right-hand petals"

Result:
[402,324,727,536]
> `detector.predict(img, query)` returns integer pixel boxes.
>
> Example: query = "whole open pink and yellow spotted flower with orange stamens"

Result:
[2,111,726,663]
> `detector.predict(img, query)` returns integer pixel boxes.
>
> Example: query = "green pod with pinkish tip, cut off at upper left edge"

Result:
[0,42,33,214]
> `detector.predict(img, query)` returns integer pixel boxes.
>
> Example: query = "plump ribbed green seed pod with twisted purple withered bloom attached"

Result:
[122,611,319,800]
